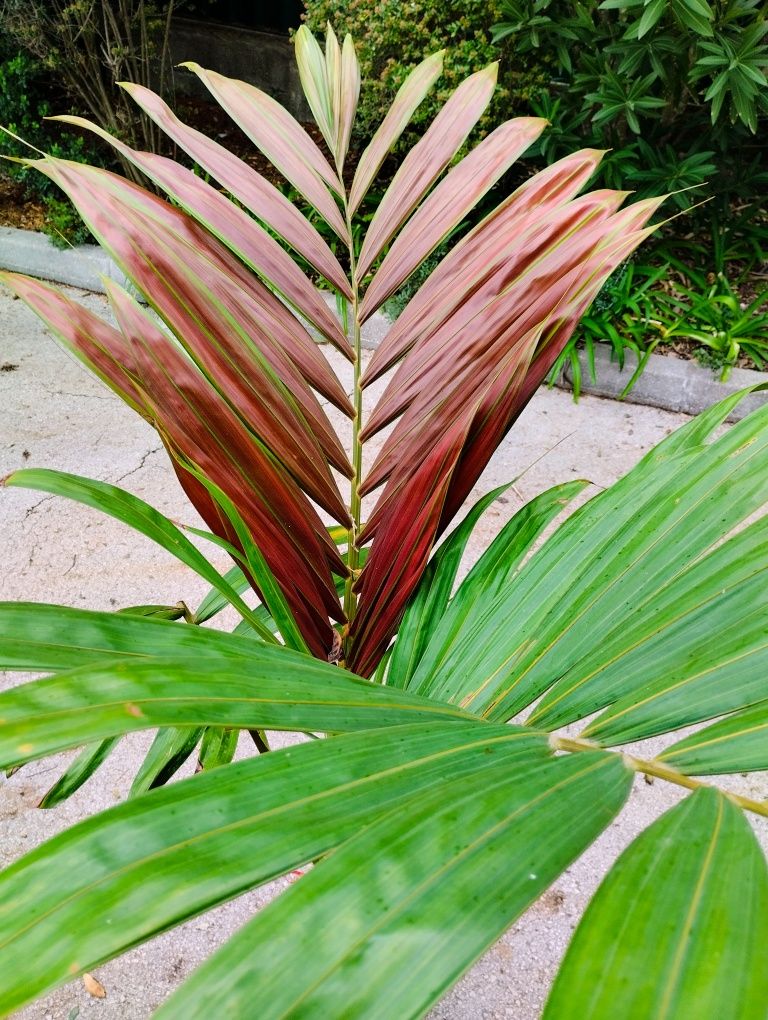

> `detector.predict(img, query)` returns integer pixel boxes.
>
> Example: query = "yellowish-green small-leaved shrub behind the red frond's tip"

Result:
[305,0,546,151]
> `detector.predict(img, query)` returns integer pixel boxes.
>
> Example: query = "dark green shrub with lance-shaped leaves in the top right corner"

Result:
[494,0,768,218]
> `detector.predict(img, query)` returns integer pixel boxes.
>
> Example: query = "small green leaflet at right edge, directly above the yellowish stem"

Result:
[657,701,768,775]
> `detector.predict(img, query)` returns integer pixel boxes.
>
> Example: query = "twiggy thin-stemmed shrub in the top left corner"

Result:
[0,0,184,247]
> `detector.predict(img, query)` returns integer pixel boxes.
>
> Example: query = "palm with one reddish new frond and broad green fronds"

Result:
[0,30,768,1018]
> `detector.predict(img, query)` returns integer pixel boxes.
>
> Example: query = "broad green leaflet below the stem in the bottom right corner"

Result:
[544,789,768,1020]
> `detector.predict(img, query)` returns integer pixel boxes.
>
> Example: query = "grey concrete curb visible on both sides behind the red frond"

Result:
[0,226,768,421]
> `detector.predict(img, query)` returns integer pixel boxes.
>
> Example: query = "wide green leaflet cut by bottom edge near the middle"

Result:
[157,753,631,1020]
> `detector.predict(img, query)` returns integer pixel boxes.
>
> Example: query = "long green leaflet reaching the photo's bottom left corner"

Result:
[0,721,550,1015]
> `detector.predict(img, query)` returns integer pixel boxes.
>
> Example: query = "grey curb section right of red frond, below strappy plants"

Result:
[557,344,768,421]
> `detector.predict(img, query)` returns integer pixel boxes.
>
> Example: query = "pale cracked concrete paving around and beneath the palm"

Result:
[0,281,768,1020]
